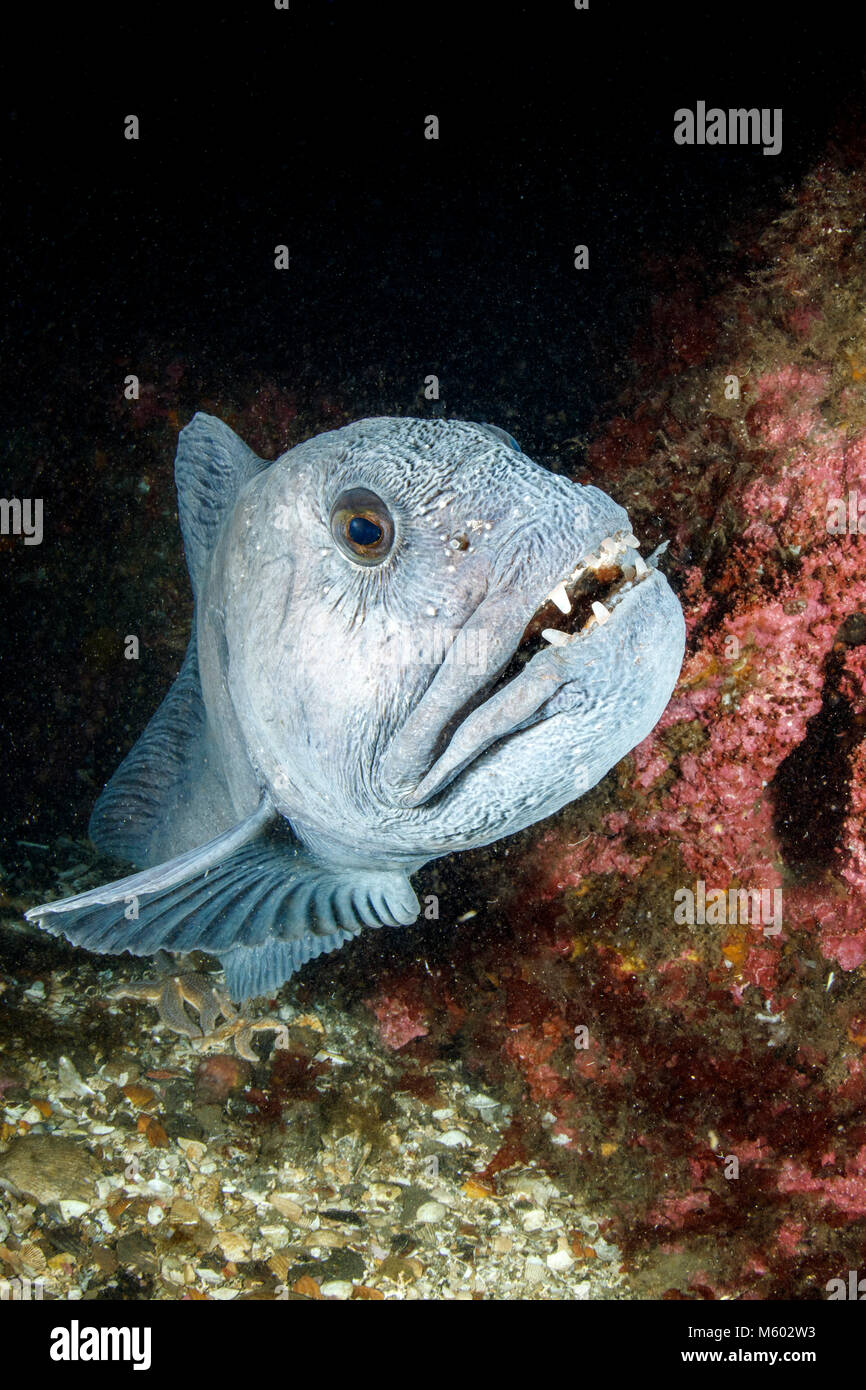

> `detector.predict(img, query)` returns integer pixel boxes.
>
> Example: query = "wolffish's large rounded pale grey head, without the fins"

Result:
[197,418,685,865]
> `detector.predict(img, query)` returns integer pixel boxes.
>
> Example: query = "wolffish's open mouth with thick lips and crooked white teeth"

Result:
[391,528,667,808]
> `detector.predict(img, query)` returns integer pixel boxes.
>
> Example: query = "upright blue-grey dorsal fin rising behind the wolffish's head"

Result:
[174,411,267,595]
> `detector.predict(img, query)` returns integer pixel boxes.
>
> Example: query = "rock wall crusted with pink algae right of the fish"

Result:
[354,125,866,1297]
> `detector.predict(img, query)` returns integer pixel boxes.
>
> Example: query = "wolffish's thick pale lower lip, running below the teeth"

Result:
[403,567,667,808]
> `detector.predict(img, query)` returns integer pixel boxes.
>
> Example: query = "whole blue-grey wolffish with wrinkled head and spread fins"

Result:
[28,414,685,999]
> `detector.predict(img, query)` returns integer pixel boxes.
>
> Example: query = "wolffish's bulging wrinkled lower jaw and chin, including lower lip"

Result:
[389,569,685,856]
